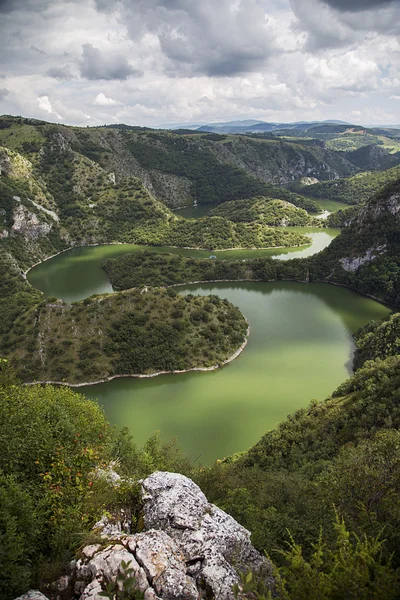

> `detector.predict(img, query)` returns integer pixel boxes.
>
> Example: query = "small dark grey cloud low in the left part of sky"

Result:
[80,44,141,81]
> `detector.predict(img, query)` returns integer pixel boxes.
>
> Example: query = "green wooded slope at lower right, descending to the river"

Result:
[195,356,400,567]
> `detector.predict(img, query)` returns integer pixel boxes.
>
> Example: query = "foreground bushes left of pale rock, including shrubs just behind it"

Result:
[0,361,195,600]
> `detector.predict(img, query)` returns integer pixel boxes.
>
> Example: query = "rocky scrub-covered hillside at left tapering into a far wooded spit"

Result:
[0,142,309,254]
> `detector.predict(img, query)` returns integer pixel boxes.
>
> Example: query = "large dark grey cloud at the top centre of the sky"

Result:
[114,0,275,77]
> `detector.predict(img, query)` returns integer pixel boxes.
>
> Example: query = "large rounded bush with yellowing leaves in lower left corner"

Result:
[0,379,112,599]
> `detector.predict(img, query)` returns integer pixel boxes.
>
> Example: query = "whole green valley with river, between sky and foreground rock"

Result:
[0,116,400,600]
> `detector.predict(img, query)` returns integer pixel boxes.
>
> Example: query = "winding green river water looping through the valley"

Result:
[28,236,390,463]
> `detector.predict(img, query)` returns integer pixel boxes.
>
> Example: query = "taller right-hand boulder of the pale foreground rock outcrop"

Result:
[142,472,268,600]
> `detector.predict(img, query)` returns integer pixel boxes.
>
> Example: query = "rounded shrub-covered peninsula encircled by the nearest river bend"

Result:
[2,289,247,384]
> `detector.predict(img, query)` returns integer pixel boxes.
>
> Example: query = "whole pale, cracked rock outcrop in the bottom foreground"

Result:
[22,472,273,600]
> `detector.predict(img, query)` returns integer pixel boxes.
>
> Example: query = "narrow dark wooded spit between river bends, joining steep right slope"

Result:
[105,177,400,306]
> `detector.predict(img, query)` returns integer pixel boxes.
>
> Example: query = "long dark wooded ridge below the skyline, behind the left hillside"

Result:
[0,117,359,211]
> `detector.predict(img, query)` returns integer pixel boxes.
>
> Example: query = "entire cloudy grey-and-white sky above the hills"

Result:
[0,0,400,126]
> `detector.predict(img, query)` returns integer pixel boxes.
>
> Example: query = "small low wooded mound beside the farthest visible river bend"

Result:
[209,196,322,227]
